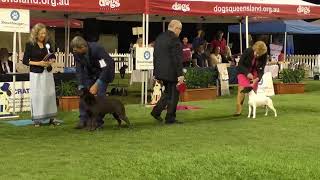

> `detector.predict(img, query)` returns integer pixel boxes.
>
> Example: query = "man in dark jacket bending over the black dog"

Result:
[71,36,115,129]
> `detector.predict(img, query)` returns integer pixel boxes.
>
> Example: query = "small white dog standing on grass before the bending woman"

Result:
[248,90,277,118]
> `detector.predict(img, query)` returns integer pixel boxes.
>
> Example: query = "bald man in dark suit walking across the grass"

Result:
[151,20,184,124]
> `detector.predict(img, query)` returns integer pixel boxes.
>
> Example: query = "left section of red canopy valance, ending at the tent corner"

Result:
[0,0,145,14]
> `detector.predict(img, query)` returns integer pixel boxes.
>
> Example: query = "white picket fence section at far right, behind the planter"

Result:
[286,54,320,77]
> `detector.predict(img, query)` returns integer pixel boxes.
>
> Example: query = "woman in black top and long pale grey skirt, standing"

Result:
[23,23,59,127]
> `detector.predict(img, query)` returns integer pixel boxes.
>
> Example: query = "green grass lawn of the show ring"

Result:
[0,81,320,180]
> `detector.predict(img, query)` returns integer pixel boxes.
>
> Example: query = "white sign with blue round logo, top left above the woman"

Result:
[0,8,30,33]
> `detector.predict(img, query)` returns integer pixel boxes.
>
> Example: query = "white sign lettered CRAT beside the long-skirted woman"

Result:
[0,81,31,114]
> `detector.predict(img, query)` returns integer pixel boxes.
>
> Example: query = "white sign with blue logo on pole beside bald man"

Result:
[136,47,153,70]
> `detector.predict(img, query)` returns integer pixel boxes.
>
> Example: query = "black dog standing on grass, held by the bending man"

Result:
[80,88,130,130]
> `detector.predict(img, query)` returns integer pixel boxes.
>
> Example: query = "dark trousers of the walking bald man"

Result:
[152,81,179,122]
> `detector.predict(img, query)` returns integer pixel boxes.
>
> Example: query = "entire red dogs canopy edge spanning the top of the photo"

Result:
[0,0,320,19]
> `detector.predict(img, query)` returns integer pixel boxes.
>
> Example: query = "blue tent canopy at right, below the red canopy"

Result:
[228,20,320,34]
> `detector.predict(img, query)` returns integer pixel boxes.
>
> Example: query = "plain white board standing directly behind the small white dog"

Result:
[257,72,274,96]
